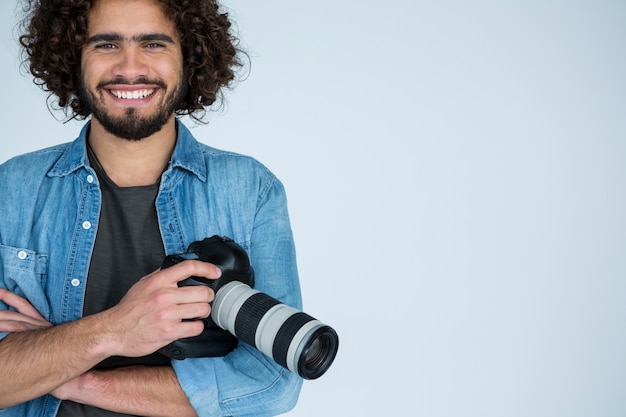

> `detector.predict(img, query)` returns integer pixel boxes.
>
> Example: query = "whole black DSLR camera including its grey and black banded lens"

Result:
[160,236,339,379]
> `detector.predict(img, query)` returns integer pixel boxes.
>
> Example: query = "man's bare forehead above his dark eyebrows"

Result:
[87,0,178,39]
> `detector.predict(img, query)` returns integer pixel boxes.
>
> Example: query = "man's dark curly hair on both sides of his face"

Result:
[19,0,245,122]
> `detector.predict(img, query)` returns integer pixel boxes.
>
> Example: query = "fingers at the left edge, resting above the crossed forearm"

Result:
[0,288,52,333]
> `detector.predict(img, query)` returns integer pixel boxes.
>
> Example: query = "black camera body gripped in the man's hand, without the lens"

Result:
[159,236,254,359]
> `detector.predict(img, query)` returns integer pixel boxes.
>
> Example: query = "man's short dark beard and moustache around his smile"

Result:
[78,74,187,141]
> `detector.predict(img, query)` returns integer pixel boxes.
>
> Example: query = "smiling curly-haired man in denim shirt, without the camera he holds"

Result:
[0,0,301,416]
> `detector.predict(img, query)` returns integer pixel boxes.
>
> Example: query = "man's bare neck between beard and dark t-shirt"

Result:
[87,117,176,187]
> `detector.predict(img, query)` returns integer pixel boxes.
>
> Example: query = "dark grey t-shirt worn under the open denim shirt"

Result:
[57,155,170,417]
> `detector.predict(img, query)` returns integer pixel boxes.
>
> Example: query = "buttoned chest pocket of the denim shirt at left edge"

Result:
[0,245,50,320]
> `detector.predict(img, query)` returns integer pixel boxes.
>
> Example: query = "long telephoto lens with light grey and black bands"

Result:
[211,281,339,379]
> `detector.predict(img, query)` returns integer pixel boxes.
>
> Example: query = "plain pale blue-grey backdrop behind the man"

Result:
[0,0,626,417]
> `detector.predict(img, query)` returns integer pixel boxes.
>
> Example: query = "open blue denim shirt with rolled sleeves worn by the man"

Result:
[0,123,302,417]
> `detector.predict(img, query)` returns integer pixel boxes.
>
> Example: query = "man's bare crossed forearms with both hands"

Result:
[0,261,220,416]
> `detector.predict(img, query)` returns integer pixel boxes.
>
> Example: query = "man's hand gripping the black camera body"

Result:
[104,261,221,357]
